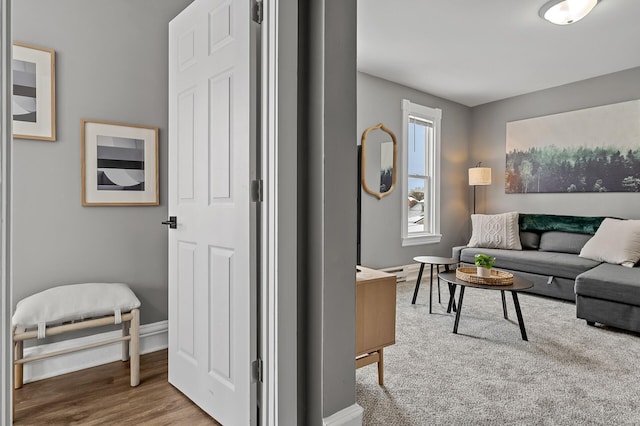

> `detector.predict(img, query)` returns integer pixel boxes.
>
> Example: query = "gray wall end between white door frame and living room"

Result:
[298,0,357,426]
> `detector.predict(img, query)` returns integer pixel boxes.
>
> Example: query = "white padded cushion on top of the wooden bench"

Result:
[12,283,140,327]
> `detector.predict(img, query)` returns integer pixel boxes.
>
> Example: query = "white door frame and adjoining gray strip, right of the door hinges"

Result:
[258,0,298,425]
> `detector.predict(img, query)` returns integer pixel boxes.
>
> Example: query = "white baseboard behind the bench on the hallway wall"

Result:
[24,321,169,383]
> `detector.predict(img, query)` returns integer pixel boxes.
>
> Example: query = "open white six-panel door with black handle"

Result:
[168,0,257,425]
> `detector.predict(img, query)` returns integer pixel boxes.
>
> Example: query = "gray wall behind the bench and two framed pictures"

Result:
[13,0,192,323]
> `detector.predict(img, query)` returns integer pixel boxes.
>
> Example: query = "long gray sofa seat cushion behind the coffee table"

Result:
[460,247,600,279]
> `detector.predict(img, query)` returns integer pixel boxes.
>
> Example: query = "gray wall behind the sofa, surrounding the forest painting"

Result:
[471,68,640,219]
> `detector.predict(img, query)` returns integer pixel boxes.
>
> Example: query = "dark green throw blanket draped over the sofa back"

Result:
[518,213,605,235]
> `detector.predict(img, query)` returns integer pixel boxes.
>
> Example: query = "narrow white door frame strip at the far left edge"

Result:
[0,0,13,425]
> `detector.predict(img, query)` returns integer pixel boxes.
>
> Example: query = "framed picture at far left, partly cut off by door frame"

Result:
[11,43,56,141]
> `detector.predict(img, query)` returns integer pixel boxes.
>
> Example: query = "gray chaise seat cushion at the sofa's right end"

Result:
[575,263,640,306]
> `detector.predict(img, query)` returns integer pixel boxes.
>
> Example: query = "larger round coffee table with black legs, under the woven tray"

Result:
[438,271,533,340]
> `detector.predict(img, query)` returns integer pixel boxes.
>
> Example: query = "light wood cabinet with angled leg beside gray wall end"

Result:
[356,266,396,385]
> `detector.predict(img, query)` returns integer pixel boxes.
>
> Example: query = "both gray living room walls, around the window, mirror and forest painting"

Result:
[357,68,640,268]
